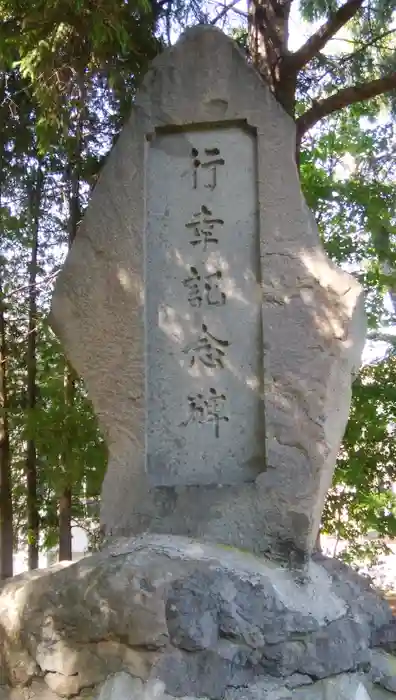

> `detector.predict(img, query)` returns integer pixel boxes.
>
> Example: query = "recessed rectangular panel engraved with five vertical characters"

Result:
[145,127,264,485]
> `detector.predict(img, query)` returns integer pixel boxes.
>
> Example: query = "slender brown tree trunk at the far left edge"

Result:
[0,278,14,579]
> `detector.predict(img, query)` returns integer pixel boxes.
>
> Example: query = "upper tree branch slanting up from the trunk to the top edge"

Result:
[287,0,364,73]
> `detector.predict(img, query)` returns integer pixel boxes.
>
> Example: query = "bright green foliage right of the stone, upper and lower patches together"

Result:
[301,105,396,562]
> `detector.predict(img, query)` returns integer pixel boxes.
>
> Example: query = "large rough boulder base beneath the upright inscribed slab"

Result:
[0,536,396,700]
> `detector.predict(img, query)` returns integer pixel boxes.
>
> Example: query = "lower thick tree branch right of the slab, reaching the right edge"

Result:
[297,72,396,139]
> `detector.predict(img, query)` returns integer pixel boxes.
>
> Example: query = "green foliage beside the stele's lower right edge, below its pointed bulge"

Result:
[323,356,396,560]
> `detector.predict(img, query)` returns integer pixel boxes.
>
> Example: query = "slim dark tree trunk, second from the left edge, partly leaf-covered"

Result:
[25,166,43,571]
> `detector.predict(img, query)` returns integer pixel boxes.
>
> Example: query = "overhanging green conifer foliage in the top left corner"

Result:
[0,0,159,152]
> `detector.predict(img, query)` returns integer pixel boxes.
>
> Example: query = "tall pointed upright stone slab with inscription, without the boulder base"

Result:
[51,27,365,560]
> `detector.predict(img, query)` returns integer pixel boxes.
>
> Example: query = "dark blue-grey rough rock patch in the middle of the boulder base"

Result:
[167,571,319,651]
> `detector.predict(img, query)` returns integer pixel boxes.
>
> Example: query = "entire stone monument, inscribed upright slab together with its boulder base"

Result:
[0,27,396,700]
